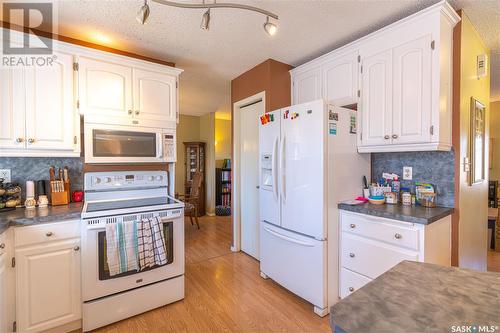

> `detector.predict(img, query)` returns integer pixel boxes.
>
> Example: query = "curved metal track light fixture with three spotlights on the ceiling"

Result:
[137,0,278,36]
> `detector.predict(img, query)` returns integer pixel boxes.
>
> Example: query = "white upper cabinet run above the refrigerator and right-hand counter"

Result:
[291,2,460,153]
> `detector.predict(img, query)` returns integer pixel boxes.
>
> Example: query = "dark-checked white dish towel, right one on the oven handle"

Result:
[137,217,167,270]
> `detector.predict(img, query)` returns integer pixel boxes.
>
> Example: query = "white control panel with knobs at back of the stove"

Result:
[84,171,168,191]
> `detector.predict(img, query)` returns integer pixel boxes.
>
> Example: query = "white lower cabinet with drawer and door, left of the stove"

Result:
[15,221,82,333]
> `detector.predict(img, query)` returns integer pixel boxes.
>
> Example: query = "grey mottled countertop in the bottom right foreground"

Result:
[330,261,500,333]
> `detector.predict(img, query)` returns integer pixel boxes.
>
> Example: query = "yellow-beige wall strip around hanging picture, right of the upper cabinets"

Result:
[453,12,490,271]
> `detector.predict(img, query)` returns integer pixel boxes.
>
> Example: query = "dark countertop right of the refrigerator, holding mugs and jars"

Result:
[338,203,453,224]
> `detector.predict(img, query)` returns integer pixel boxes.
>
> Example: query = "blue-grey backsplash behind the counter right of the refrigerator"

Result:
[371,150,455,207]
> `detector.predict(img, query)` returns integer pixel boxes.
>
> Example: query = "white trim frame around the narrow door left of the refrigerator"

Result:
[231,91,266,252]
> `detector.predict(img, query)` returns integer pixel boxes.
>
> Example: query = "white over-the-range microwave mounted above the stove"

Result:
[83,124,176,164]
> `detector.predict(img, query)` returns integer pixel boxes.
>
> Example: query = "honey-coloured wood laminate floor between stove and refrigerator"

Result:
[86,217,331,333]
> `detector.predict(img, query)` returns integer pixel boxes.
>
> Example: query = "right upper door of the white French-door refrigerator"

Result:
[279,100,326,239]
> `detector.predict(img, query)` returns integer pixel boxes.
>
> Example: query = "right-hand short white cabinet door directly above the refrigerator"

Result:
[322,51,359,106]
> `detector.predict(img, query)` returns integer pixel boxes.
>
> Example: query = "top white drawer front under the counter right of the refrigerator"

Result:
[341,212,420,251]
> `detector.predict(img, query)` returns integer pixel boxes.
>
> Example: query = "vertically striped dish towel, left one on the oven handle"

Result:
[106,221,139,276]
